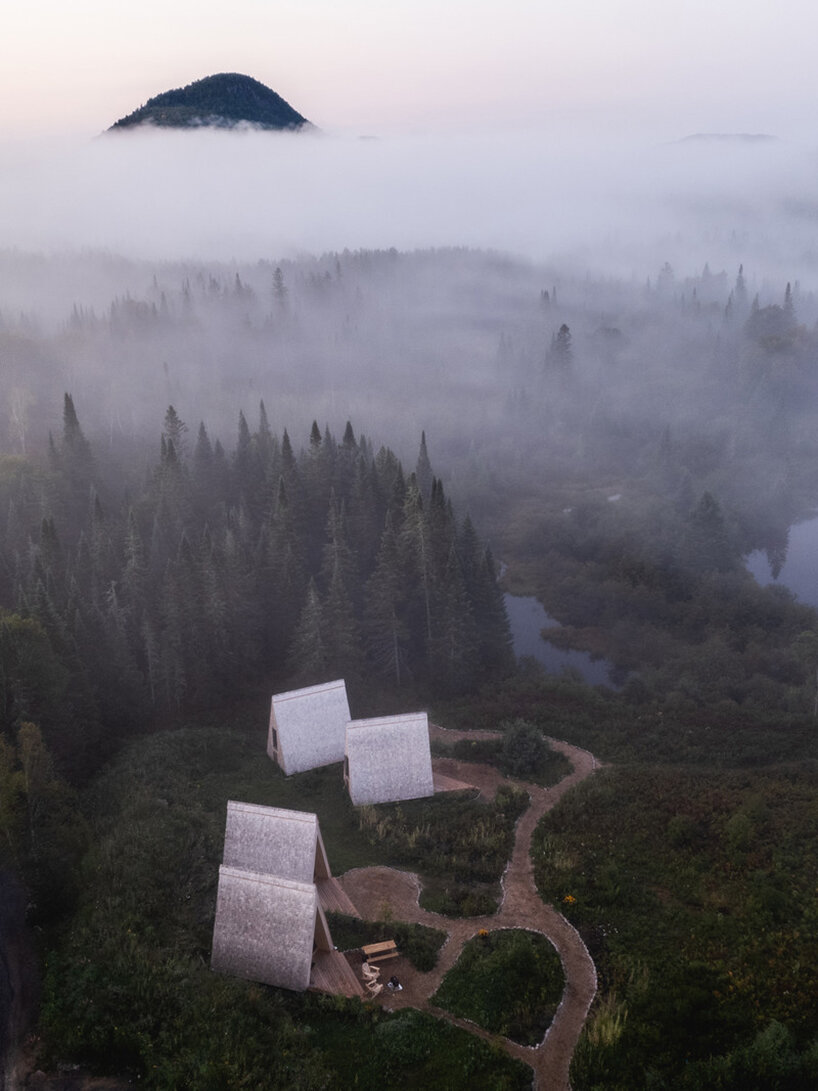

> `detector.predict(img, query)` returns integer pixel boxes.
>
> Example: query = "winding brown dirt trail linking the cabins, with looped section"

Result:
[339,728,599,1091]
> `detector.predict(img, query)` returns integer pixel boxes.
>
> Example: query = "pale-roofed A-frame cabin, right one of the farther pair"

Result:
[344,712,434,806]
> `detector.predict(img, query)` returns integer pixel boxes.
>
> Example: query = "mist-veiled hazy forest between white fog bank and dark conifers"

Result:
[0,212,818,532]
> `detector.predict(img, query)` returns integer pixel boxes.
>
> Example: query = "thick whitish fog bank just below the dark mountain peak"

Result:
[0,128,816,279]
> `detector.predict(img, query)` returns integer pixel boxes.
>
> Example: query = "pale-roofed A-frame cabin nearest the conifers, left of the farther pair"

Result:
[267,679,349,776]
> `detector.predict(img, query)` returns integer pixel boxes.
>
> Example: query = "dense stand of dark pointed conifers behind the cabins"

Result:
[0,395,514,778]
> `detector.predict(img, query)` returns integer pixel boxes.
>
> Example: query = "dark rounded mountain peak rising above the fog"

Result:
[108,72,312,132]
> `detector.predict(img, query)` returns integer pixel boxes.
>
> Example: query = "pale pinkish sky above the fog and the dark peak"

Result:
[0,0,818,140]
